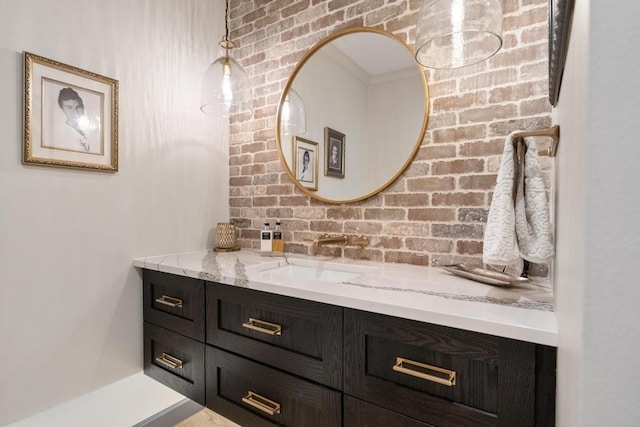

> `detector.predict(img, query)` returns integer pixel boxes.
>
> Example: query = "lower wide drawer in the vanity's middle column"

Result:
[206,346,342,427]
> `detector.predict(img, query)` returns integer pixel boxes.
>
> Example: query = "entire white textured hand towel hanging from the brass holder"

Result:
[483,135,554,265]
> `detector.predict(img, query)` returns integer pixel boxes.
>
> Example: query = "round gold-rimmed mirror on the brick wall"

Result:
[276,28,429,203]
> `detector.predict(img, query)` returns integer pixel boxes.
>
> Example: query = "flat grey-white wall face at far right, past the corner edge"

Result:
[583,0,640,426]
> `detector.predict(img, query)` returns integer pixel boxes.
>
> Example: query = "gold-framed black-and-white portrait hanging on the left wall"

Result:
[22,52,118,172]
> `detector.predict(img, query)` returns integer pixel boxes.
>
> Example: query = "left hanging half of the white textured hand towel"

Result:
[482,135,520,265]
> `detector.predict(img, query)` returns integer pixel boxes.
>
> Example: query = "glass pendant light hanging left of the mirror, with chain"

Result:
[200,0,253,117]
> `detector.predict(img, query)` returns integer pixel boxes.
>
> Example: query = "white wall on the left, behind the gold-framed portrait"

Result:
[0,0,228,425]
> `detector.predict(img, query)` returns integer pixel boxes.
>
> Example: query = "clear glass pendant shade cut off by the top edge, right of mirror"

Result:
[415,0,502,68]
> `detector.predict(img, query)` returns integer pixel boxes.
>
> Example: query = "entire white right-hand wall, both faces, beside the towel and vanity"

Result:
[556,0,640,427]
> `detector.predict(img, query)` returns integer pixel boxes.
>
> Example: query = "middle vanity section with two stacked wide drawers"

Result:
[206,283,343,427]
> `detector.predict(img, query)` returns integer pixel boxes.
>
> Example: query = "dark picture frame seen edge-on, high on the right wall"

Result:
[549,0,574,107]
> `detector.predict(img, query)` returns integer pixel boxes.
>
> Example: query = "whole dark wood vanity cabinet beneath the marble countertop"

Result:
[144,270,556,427]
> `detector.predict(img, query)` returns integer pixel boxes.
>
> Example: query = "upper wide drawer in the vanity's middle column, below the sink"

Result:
[207,283,342,389]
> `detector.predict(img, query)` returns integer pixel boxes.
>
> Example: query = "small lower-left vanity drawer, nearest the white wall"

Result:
[144,322,205,405]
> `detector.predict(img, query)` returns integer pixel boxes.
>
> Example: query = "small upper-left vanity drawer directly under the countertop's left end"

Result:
[142,270,205,341]
